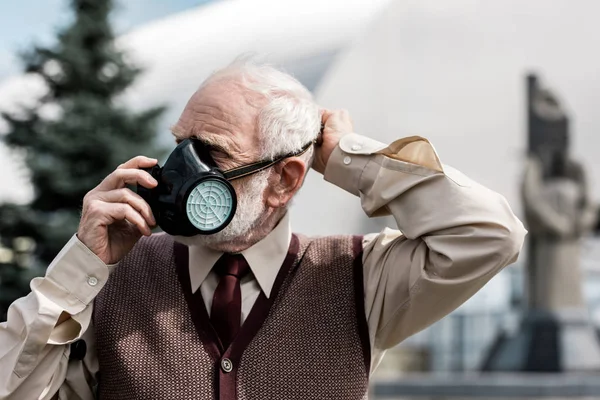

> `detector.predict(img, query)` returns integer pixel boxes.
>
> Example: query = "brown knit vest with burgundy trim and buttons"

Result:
[94,234,370,400]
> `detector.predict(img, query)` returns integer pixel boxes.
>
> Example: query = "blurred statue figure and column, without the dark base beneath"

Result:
[522,83,597,312]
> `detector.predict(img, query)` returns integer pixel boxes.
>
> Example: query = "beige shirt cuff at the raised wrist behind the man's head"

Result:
[324,133,386,196]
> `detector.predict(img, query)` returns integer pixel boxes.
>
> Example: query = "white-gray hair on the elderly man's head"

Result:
[203,56,321,166]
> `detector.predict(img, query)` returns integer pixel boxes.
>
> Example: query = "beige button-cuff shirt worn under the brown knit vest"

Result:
[0,134,526,400]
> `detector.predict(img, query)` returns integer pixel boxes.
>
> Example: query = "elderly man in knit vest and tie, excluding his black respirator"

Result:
[0,62,525,400]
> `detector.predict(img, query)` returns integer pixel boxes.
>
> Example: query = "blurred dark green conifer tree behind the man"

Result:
[0,0,163,320]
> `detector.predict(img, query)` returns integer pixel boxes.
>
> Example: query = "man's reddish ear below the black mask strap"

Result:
[265,157,307,208]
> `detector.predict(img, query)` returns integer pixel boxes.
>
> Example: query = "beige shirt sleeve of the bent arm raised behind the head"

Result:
[325,134,526,367]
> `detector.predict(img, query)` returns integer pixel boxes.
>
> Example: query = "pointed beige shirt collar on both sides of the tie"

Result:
[189,213,292,298]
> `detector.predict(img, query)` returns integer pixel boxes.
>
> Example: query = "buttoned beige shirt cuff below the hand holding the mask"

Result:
[32,235,114,315]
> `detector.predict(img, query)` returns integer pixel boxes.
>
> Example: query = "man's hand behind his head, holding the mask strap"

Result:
[312,110,354,174]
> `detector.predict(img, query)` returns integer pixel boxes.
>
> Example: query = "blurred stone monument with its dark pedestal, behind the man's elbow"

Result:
[482,75,600,372]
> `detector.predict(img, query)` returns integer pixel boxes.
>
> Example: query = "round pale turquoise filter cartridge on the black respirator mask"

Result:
[185,179,235,232]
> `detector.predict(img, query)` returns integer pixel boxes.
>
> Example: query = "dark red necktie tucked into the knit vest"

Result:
[210,254,250,349]
